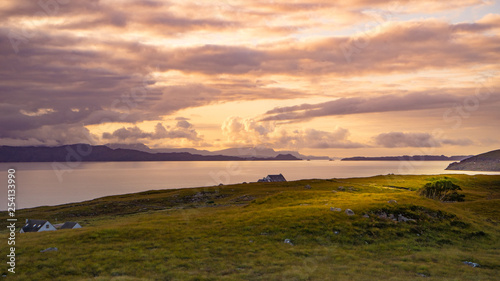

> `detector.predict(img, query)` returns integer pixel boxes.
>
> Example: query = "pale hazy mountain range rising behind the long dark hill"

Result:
[106,143,330,160]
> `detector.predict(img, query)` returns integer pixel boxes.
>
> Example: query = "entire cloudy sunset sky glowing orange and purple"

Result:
[0,0,500,157]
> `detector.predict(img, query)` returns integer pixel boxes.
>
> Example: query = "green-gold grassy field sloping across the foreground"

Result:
[0,175,500,281]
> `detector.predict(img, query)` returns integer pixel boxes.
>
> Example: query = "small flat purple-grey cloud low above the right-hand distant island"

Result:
[374,132,473,148]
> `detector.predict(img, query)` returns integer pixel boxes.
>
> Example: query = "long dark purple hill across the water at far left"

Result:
[0,144,301,162]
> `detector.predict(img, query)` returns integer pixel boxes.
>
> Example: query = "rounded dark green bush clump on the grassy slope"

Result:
[419,180,465,202]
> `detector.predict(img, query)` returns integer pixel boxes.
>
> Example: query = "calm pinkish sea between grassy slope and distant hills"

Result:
[0,160,500,211]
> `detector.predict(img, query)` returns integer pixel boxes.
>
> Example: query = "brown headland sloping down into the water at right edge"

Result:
[446,149,500,171]
